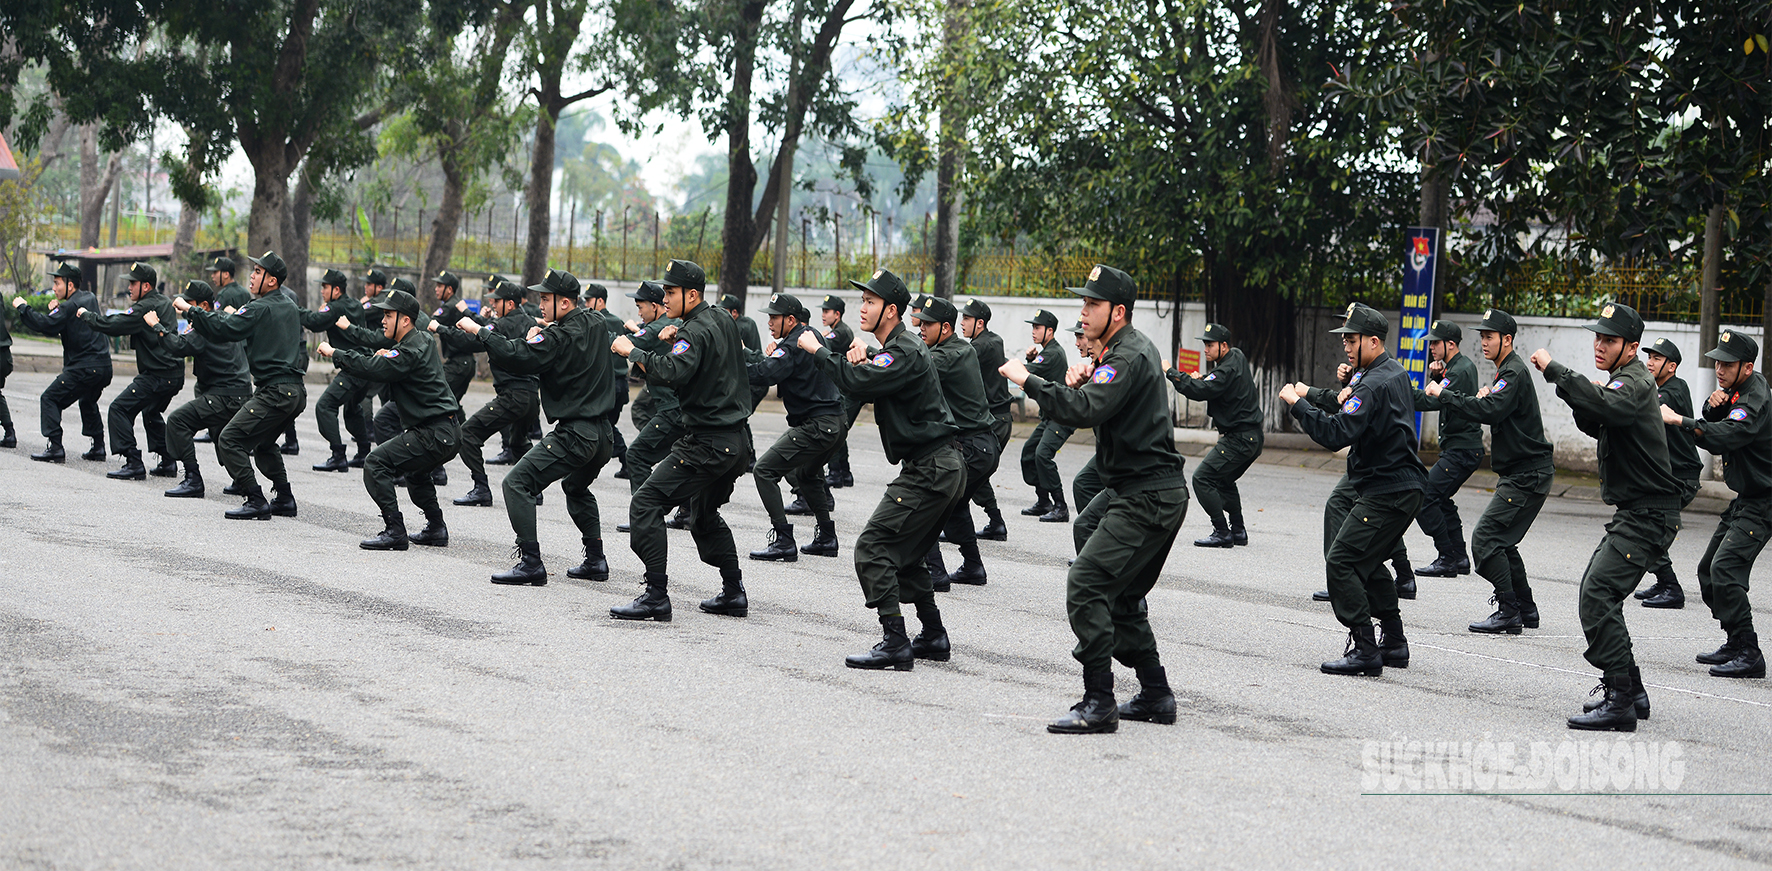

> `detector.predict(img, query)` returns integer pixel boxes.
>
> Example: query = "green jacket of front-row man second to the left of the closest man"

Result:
[627,301,751,432]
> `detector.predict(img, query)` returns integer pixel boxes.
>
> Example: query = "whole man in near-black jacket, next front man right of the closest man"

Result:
[1279,303,1428,676]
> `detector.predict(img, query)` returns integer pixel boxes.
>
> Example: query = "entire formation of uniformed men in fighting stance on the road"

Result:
[0,251,1772,733]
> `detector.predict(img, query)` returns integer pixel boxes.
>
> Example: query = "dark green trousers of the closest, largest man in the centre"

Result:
[1065,487,1187,673]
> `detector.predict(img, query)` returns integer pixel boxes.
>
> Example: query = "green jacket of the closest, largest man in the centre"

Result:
[1022,326,1187,496]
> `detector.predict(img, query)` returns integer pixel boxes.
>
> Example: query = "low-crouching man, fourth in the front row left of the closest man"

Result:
[319,290,461,551]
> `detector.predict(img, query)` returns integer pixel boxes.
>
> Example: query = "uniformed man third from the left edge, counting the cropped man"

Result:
[74,262,184,482]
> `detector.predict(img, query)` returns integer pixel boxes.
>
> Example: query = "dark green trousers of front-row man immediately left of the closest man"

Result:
[856,443,966,616]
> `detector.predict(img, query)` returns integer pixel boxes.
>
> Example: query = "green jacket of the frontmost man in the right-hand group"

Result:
[1545,358,1680,508]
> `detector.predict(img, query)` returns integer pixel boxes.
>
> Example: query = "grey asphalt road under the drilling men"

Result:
[0,374,1772,869]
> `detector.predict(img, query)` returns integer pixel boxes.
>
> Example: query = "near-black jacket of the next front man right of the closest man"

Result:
[1292,354,1428,496]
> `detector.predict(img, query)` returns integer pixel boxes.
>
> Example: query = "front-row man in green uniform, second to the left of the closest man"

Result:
[610,260,751,621]
